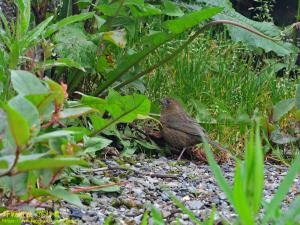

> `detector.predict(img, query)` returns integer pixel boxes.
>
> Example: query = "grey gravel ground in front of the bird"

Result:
[52,156,300,224]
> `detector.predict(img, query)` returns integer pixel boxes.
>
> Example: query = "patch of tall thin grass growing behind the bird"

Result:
[145,34,299,153]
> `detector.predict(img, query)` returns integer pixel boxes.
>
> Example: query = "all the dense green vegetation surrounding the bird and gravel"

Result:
[0,0,300,224]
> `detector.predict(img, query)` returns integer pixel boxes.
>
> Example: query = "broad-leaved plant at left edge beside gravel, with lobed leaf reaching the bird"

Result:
[0,70,150,206]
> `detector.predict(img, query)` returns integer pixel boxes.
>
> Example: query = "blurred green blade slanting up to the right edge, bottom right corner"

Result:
[262,155,300,225]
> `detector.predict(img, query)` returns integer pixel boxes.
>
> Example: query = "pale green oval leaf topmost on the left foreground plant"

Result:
[11,70,49,95]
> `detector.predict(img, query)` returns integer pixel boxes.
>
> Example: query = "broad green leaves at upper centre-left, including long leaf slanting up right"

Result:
[49,1,220,95]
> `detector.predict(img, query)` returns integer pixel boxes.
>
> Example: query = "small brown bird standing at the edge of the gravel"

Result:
[160,98,226,160]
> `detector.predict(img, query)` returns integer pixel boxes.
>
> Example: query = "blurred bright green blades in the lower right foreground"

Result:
[205,123,300,224]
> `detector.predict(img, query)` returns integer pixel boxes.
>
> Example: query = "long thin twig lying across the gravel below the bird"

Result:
[80,166,178,179]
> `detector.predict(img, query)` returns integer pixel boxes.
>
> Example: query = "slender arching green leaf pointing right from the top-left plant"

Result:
[45,12,94,38]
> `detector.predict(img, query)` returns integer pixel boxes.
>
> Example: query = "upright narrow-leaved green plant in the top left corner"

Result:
[0,1,93,99]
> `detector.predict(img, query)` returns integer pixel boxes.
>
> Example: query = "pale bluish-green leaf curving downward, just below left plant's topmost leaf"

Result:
[9,95,41,134]
